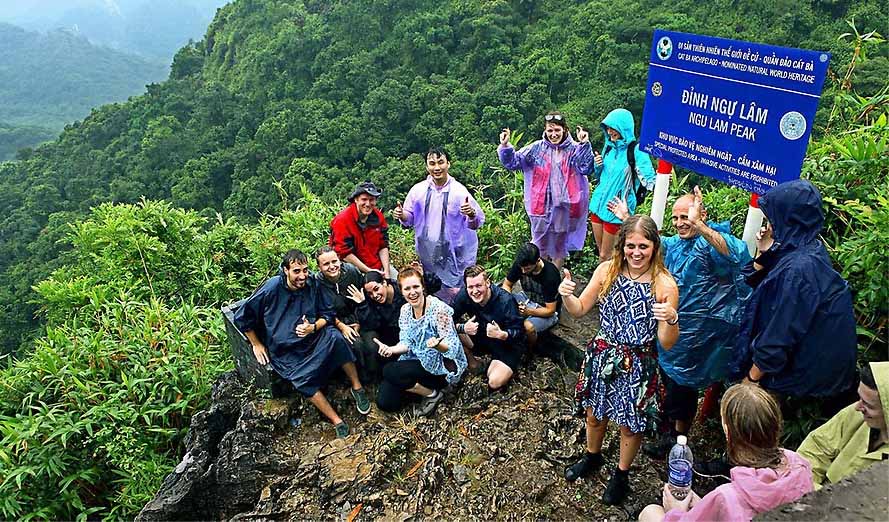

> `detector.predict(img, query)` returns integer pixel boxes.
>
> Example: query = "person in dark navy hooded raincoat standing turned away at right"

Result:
[732,180,857,416]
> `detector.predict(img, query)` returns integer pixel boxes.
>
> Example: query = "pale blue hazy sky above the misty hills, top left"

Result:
[0,0,228,63]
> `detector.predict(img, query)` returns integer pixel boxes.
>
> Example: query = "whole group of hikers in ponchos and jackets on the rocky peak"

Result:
[235,109,889,520]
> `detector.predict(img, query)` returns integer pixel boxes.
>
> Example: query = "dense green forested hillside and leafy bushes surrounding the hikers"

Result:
[0,0,889,519]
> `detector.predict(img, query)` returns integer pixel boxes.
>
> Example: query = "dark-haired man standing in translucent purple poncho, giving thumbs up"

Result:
[393,147,485,304]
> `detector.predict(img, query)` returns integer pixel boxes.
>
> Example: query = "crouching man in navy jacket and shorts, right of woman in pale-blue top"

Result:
[454,265,525,390]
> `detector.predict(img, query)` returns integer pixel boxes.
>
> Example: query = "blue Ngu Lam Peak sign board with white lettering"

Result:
[639,30,830,194]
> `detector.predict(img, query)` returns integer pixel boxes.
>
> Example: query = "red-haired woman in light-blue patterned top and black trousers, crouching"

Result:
[376,268,466,416]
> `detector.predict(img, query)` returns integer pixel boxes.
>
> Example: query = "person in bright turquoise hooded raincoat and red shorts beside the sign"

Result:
[590,109,655,263]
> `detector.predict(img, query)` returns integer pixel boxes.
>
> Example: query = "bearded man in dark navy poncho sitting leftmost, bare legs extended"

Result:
[234,249,370,438]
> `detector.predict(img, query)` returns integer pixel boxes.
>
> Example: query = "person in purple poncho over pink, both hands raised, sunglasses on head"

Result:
[497,112,593,269]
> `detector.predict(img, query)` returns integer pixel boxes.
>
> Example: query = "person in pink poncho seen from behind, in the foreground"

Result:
[639,383,813,522]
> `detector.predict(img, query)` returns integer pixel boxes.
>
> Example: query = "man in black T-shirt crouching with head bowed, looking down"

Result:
[503,242,562,349]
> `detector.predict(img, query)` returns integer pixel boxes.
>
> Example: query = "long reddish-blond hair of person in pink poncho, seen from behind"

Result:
[720,383,784,468]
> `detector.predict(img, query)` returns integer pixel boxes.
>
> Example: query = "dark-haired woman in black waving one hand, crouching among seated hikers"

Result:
[346,270,405,381]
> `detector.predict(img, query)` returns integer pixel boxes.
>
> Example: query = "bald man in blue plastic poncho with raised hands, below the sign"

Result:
[609,187,750,458]
